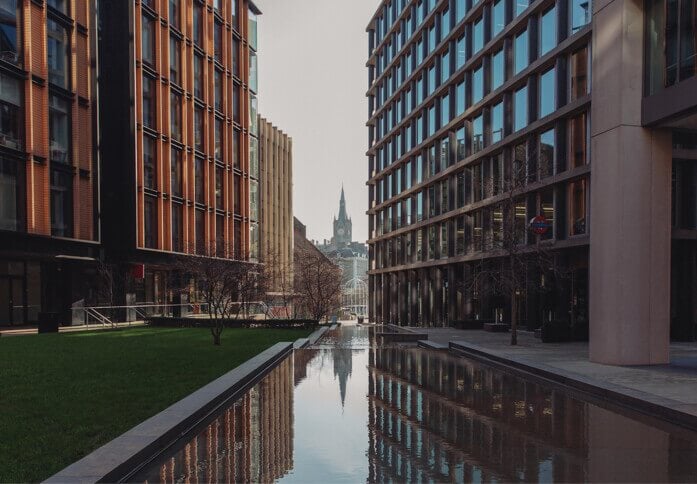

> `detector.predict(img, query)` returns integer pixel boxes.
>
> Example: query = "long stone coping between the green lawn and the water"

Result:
[45,342,293,483]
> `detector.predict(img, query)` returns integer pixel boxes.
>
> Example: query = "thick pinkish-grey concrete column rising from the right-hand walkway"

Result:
[590,0,672,365]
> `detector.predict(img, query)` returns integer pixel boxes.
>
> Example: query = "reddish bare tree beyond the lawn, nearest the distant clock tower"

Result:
[294,247,341,320]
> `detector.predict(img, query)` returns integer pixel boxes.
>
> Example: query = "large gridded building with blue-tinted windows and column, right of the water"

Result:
[367,0,697,364]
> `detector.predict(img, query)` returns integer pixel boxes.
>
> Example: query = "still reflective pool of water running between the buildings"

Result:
[134,326,697,483]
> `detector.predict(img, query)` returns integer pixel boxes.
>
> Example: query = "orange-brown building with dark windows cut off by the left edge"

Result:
[0,0,100,325]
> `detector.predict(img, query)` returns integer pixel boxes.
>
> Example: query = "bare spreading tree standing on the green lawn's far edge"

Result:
[179,242,265,346]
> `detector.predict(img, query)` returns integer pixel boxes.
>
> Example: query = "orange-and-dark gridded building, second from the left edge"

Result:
[99,0,260,310]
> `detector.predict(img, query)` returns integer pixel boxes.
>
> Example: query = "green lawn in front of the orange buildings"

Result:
[0,328,310,482]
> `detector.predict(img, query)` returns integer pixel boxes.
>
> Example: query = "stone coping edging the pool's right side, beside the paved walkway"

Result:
[449,341,697,431]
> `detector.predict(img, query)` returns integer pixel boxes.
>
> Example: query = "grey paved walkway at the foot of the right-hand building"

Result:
[419,328,697,424]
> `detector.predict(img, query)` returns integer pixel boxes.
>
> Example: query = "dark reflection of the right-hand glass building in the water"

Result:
[368,347,697,482]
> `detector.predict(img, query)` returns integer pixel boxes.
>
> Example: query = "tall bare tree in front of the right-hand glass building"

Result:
[464,141,565,345]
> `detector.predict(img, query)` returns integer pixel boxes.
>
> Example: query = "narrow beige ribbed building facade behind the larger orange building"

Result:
[259,116,293,309]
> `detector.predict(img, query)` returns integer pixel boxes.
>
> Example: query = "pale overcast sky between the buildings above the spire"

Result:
[255,0,380,241]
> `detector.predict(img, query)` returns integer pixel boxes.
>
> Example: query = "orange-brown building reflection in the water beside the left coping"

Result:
[139,358,293,483]
